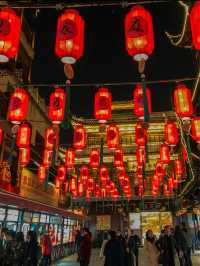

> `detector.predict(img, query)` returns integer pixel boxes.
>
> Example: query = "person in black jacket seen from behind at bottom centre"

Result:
[104,231,124,266]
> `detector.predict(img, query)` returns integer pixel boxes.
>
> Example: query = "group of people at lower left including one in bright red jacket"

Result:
[0,228,52,266]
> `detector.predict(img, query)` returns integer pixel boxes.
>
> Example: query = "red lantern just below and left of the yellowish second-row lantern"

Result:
[165,122,179,146]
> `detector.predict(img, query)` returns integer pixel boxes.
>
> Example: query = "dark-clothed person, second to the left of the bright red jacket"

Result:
[13,232,26,266]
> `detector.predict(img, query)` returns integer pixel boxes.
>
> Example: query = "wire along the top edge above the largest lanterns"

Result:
[0,0,170,10]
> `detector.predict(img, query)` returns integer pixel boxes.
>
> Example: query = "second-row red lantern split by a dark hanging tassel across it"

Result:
[133,84,152,119]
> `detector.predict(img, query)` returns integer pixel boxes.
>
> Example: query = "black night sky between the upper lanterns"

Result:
[32,1,197,115]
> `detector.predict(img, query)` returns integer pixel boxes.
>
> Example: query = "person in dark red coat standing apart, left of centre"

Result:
[79,228,92,266]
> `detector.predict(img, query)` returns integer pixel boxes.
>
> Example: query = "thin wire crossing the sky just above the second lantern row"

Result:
[0,77,197,88]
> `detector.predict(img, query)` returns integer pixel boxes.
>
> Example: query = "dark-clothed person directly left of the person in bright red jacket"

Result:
[25,231,39,266]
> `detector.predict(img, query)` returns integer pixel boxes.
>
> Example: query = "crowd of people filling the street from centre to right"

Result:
[76,222,195,266]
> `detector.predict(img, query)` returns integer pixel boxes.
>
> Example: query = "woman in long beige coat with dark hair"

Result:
[144,230,159,266]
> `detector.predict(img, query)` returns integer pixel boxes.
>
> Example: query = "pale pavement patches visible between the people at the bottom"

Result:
[55,249,200,266]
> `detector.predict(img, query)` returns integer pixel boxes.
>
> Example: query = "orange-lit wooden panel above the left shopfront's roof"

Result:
[20,168,59,207]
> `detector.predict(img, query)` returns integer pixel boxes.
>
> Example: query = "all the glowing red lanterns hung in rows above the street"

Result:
[0,1,200,199]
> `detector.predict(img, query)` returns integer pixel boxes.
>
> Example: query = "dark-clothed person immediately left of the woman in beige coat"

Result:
[128,230,141,266]
